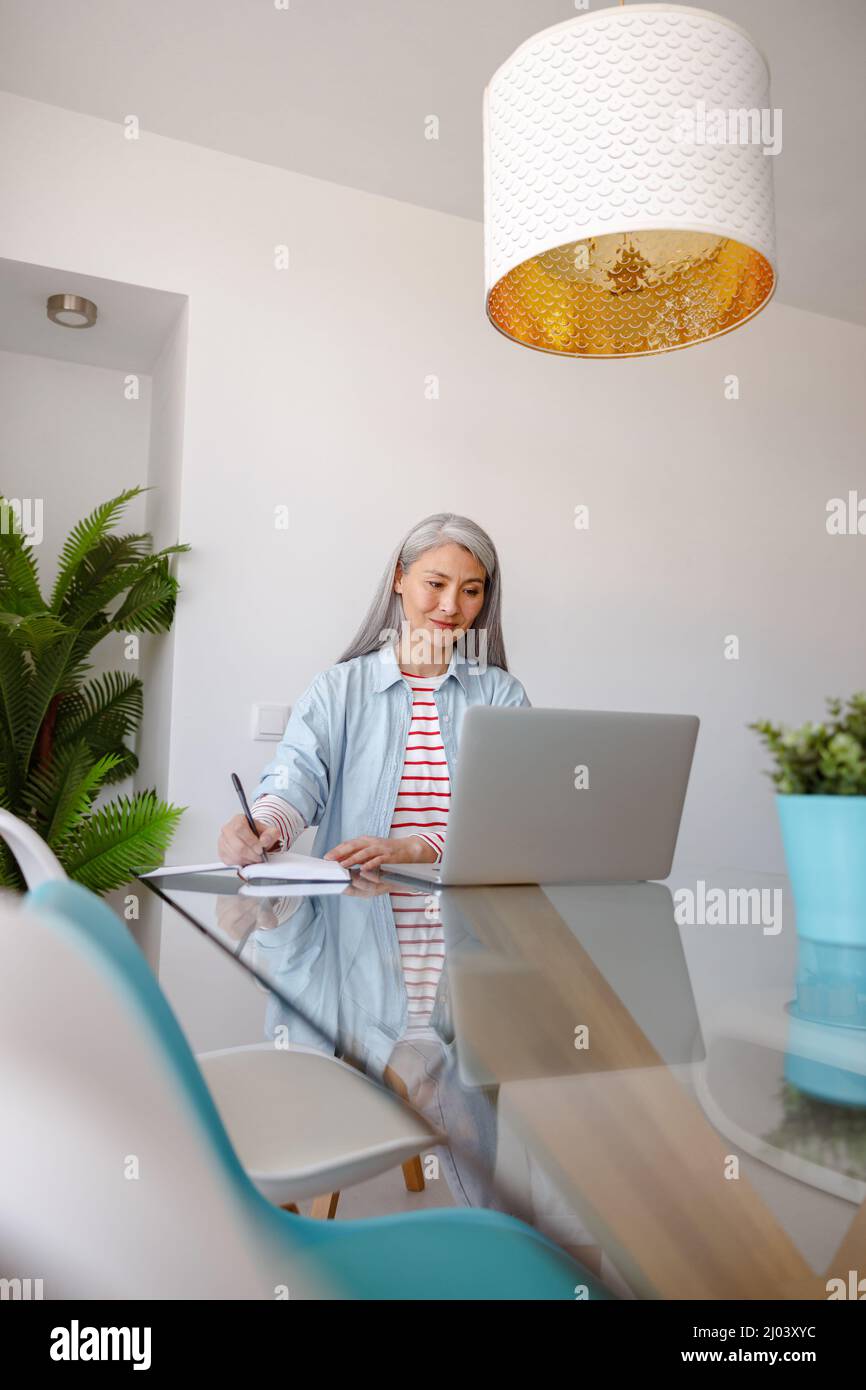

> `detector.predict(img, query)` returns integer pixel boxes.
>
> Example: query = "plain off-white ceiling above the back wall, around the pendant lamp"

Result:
[0,0,866,324]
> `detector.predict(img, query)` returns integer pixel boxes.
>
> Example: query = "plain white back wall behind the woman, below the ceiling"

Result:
[0,93,866,867]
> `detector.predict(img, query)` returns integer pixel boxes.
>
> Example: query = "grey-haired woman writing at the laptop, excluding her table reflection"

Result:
[218,513,530,872]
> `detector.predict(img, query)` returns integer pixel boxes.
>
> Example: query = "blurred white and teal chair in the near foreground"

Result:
[0,880,610,1301]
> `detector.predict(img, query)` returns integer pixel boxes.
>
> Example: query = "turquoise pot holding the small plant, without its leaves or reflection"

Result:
[776,795,866,947]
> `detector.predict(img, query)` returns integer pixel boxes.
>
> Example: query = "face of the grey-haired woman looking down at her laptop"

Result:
[393,541,485,656]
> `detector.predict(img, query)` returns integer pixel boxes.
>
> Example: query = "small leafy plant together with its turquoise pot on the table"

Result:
[748,691,866,947]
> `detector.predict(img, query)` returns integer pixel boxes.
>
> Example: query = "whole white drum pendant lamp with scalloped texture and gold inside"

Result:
[484,4,780,357]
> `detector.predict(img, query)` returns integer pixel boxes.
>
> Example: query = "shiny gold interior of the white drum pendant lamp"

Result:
[487,231,774,357]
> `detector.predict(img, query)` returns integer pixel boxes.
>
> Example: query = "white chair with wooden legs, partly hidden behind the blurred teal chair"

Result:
[0,810,441,1218]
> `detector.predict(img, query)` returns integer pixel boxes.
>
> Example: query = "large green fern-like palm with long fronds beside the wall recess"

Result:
[0,488,189,894]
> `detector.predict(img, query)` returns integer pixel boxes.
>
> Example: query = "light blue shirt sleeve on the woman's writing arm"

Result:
[253,681,331,826]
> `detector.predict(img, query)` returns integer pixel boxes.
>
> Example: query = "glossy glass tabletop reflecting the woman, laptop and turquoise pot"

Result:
[140,869,866,1300]
